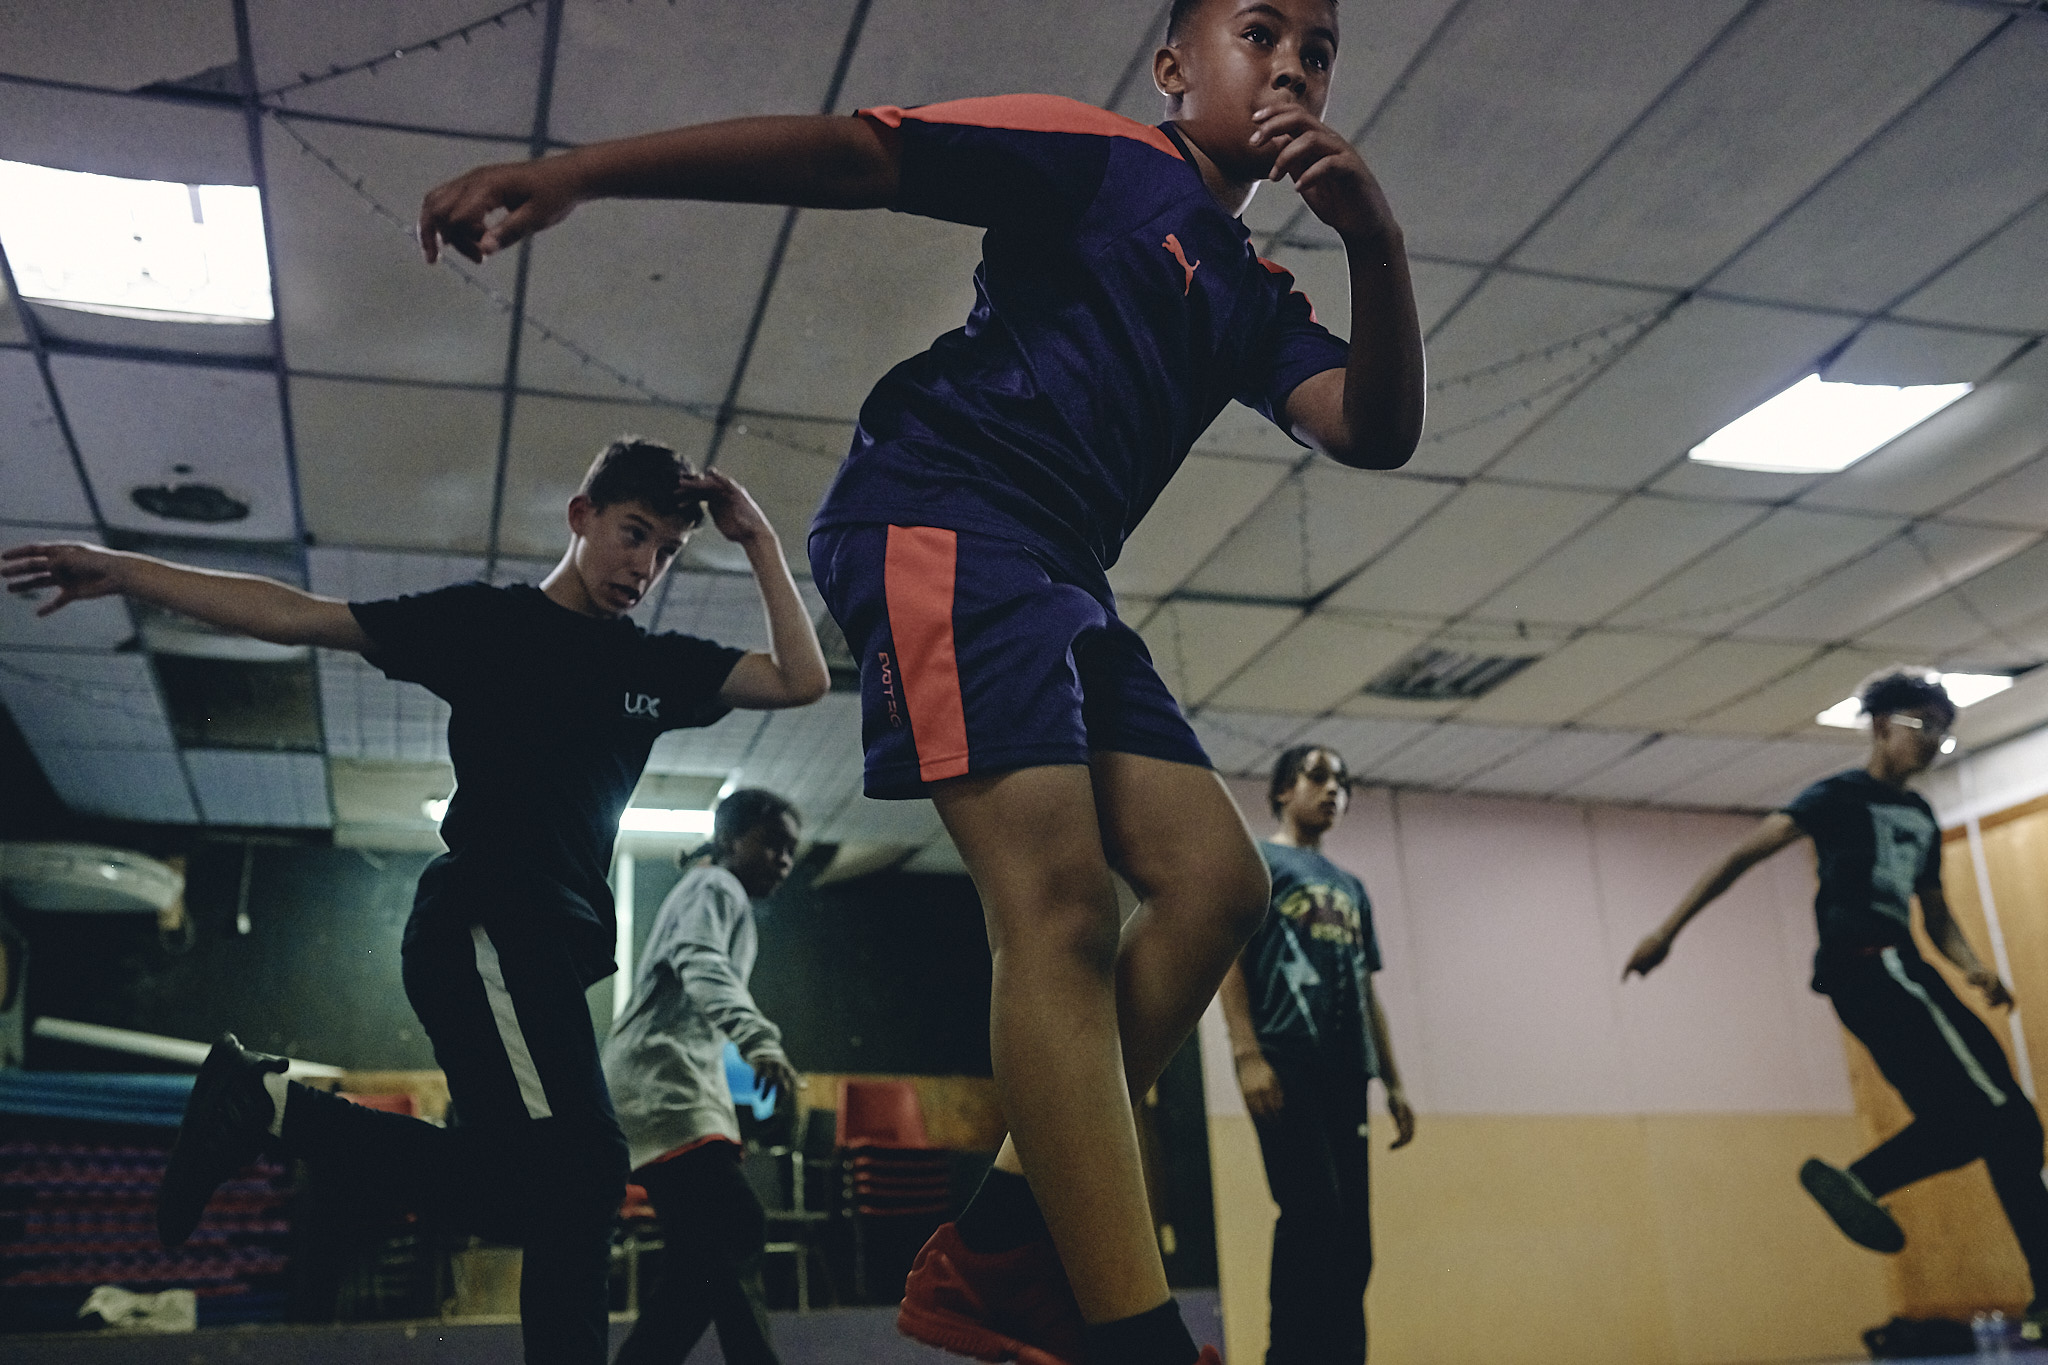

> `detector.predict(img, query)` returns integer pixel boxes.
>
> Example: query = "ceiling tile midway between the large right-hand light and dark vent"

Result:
[1473,495,1763,624]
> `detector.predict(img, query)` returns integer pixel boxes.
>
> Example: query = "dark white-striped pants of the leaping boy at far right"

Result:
[1821,948,2048,1293]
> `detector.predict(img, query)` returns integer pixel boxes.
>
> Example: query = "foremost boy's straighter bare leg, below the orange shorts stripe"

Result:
[932,763,1171,1322]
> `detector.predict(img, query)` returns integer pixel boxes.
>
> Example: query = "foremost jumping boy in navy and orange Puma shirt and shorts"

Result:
[407,0,1423,1365]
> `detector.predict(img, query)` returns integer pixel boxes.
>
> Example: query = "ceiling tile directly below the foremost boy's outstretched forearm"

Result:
[518,201,790,411]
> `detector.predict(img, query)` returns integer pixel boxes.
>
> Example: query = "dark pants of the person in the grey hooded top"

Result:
[614,1142,776,1365]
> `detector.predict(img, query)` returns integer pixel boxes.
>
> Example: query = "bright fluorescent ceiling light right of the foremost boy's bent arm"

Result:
[1688,375,1974,475]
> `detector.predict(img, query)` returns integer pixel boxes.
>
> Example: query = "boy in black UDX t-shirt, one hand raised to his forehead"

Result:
[4,438,829,1365]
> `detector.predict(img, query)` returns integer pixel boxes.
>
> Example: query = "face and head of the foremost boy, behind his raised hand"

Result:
[1153,0,1337,180]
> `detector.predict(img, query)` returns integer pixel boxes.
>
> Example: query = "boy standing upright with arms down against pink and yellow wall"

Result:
[1219,745,1415,1365]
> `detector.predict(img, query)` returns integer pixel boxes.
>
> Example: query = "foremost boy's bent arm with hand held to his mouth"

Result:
[1255,104,1423,469]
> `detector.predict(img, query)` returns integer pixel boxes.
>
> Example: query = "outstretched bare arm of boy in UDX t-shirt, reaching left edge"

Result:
[0,540,371,653]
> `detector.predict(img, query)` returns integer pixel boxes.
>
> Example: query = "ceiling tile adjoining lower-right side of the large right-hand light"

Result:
[1800,341,2048,516]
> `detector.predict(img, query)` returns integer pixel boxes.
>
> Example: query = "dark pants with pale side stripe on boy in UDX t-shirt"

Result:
[283,923,627,1365]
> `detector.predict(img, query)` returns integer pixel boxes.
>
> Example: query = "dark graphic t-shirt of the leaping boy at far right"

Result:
[1784,767,1942,960]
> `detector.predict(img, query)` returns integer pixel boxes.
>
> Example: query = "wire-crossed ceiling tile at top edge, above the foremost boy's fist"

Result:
[248,0,544,139]
